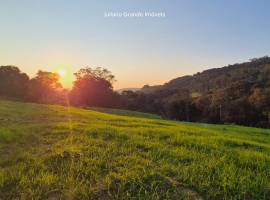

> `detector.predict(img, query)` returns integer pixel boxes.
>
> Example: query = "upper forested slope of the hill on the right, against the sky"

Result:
[141,56,270,93]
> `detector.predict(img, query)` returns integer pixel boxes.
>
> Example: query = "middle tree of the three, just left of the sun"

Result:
[26,70,62,103]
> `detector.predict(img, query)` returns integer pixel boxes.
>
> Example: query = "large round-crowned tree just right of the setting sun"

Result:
[69,67,115,107]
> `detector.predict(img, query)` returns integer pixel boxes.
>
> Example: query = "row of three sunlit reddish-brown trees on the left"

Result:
[0,66,118,107]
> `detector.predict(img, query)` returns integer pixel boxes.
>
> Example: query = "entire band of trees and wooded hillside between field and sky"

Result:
[0,56,270,128]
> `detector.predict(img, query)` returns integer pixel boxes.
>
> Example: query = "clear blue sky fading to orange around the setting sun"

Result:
[0,0,270,89]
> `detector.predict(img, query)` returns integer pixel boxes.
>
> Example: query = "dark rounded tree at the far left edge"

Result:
[0,65,29,99]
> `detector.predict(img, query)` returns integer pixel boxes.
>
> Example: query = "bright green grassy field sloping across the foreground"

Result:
[0,101,270,200]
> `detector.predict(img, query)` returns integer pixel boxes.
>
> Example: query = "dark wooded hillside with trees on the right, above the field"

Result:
[121,56,270,128]
